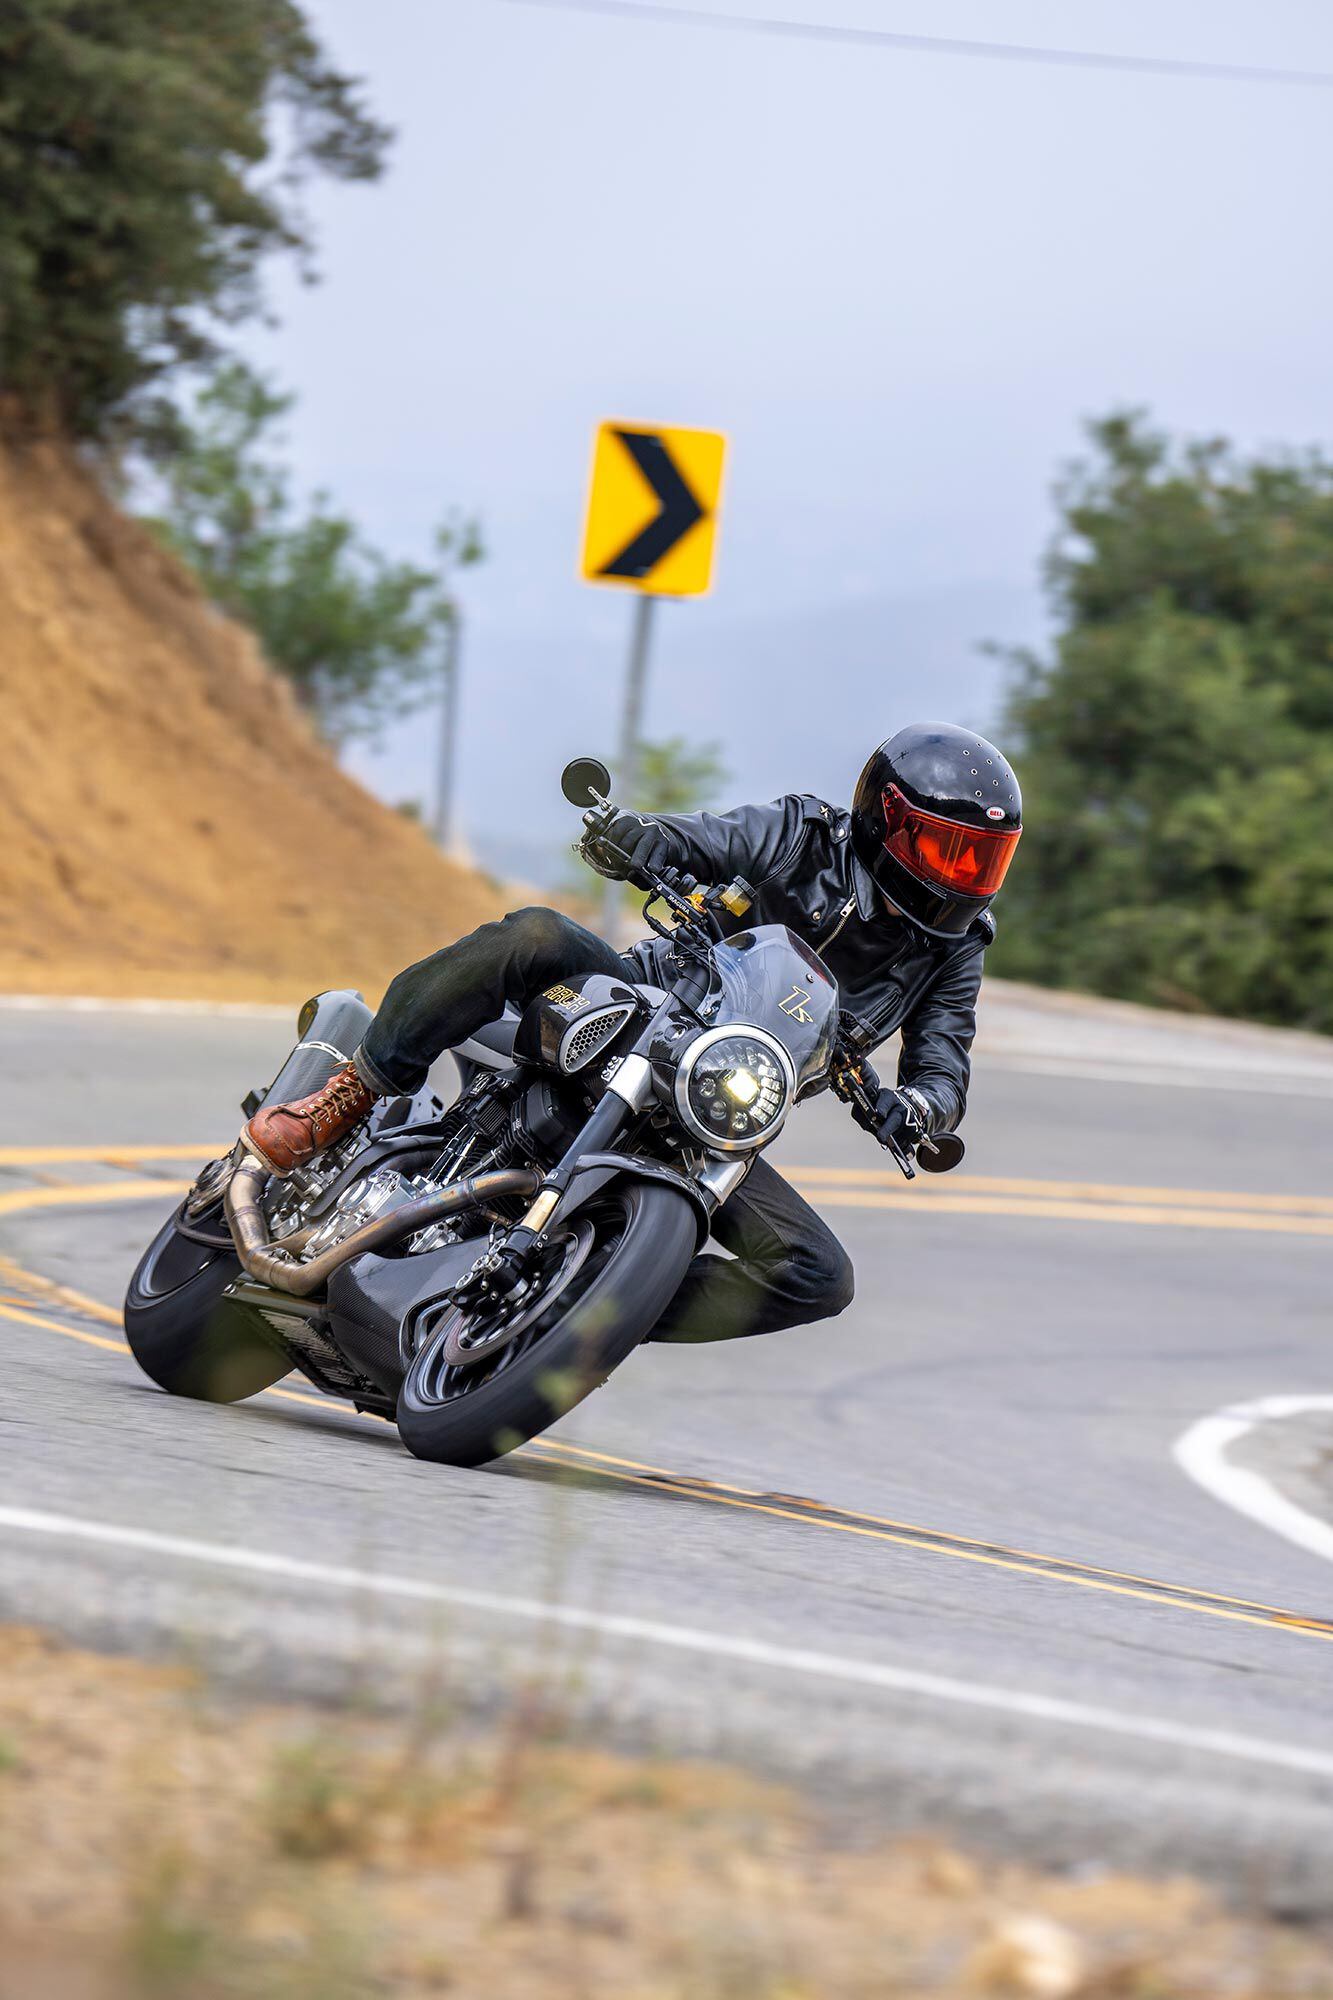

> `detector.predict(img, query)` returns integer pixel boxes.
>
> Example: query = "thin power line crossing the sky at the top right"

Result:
[496,0,1333,90]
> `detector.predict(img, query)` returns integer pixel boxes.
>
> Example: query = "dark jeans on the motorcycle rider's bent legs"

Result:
[356,910,853,1340]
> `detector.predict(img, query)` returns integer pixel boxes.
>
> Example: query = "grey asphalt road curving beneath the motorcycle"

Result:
[0,1008,1333,1916]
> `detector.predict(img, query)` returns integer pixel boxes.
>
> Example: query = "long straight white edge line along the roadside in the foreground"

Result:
[0,1506,1333,1780]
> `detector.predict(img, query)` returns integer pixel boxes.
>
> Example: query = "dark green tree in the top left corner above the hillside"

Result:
[0,0,388,436]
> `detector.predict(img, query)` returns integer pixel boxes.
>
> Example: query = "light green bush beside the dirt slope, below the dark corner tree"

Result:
[145,362,482,742]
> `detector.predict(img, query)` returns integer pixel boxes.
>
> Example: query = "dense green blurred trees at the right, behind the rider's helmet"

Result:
[995,412,1333,1032]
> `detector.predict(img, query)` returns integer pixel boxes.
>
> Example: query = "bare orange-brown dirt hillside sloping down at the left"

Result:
[0,432,500,1000]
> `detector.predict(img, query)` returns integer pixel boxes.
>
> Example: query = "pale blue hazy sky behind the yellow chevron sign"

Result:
[246,0,1333,872]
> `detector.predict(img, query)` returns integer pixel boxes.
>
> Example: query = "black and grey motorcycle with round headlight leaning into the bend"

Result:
[124,760,963,1466]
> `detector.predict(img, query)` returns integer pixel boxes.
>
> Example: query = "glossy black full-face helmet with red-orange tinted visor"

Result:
[853,722,1023,938]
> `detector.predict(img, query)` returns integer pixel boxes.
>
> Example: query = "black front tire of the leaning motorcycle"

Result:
[398,1180,697,1466]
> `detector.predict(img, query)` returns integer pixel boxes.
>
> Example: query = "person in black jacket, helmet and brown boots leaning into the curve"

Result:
[242,722,1023,1340]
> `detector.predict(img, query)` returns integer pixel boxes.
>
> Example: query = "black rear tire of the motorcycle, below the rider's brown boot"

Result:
[124,1206,292,1402]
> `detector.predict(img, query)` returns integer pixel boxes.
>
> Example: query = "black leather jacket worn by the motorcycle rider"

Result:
[628,792,995,1130]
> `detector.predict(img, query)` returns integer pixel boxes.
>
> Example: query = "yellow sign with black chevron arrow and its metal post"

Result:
[582,424,727,930]
